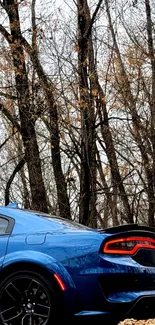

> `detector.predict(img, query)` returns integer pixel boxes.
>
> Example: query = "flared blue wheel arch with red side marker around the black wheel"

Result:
[0,251,77,313]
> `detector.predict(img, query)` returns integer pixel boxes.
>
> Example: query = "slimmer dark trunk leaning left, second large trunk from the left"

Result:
[13,12,71,219]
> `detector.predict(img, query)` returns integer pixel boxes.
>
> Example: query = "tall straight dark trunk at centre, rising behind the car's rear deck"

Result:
[77,0,97,228]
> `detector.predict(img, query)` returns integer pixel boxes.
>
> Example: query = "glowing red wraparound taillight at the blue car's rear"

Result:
[103,237,155,255]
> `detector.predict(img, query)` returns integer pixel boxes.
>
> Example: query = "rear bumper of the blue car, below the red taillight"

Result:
[65,255,155,324]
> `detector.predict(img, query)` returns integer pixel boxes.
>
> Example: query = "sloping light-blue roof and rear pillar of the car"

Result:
[0,206,92,234]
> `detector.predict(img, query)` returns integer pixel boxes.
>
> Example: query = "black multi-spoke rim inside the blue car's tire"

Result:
[0,275,51,325]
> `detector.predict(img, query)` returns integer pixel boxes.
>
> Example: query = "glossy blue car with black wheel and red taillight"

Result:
[0,204,155,325]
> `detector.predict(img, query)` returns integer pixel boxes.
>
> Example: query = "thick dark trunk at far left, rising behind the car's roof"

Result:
[5,0,47,212]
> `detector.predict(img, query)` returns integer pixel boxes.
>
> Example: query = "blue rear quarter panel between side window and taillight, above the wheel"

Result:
[3,231,108,310]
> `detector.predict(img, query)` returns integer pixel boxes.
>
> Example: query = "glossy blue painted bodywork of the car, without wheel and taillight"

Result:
[0,206,155,318]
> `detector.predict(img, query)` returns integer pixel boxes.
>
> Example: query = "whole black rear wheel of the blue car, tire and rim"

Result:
[0,270,62,325]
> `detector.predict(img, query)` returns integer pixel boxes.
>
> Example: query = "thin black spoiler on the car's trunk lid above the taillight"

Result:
[99,223,155,234]
